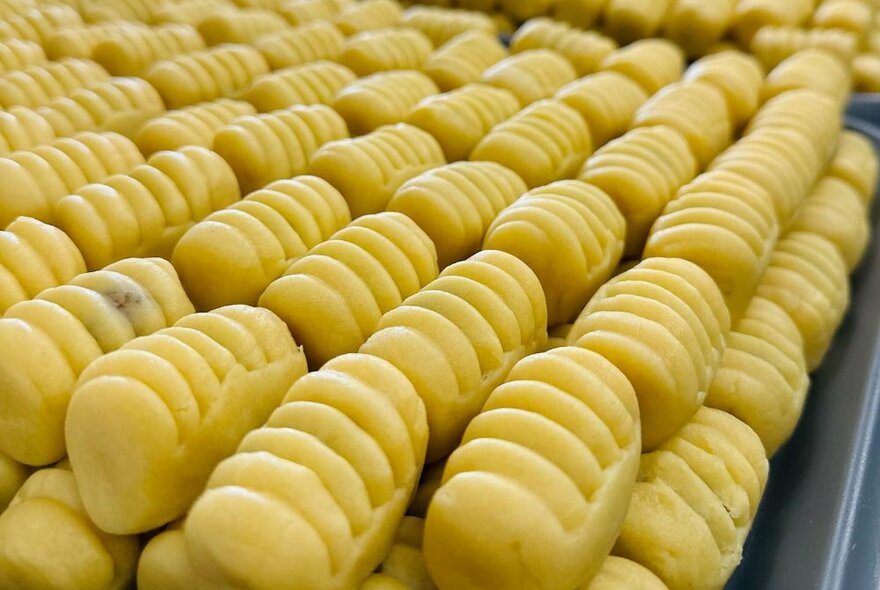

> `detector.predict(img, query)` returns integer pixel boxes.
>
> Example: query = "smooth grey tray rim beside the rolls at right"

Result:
[726,114,880,590]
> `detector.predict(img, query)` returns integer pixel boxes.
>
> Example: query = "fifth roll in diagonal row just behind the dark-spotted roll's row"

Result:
[422,30,507,92]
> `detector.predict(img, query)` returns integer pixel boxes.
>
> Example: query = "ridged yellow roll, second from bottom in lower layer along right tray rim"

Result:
[706,297,810,457]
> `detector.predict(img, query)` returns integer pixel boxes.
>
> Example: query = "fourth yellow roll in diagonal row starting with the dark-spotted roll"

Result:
[406,83,519,162]
